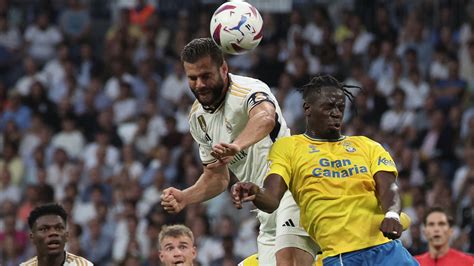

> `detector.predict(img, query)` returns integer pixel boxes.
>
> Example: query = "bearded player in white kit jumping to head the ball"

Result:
[162,38,318,265]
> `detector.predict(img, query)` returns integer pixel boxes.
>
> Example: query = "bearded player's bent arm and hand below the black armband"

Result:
[211,101,276,167]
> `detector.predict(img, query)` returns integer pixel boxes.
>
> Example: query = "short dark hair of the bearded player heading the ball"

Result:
[181,38,224,66]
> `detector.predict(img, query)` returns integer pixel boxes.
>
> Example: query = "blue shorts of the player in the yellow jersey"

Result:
[323,240,420,266]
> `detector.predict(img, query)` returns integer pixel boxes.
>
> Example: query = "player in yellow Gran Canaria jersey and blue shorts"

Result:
[232,76,418,266]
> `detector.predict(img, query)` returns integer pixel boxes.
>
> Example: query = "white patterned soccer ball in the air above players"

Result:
[210,1,263,55]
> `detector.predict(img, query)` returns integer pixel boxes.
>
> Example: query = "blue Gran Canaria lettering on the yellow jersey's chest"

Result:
[311,158,369,178]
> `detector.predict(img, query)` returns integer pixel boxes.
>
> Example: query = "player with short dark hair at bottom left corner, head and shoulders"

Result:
[20,204,93,266]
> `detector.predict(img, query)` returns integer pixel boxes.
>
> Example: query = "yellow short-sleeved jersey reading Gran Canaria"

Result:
[267,135,398,258]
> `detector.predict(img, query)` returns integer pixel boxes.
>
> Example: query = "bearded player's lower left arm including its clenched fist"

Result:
[161,163,229,213]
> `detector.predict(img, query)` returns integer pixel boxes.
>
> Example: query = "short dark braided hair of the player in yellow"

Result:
[299,75,361,102]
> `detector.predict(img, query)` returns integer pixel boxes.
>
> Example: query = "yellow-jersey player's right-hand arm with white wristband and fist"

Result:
[374,171,403,239]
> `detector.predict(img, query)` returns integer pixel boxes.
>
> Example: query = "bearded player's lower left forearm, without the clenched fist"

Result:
[183,170,229,205]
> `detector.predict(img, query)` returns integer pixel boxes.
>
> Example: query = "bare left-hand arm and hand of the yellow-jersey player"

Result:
[231,174,288,213]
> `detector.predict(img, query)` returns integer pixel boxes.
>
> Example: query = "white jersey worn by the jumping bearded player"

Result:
[189,74,290,186]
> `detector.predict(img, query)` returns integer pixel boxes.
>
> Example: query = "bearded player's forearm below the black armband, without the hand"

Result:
[233,108,275,150]
